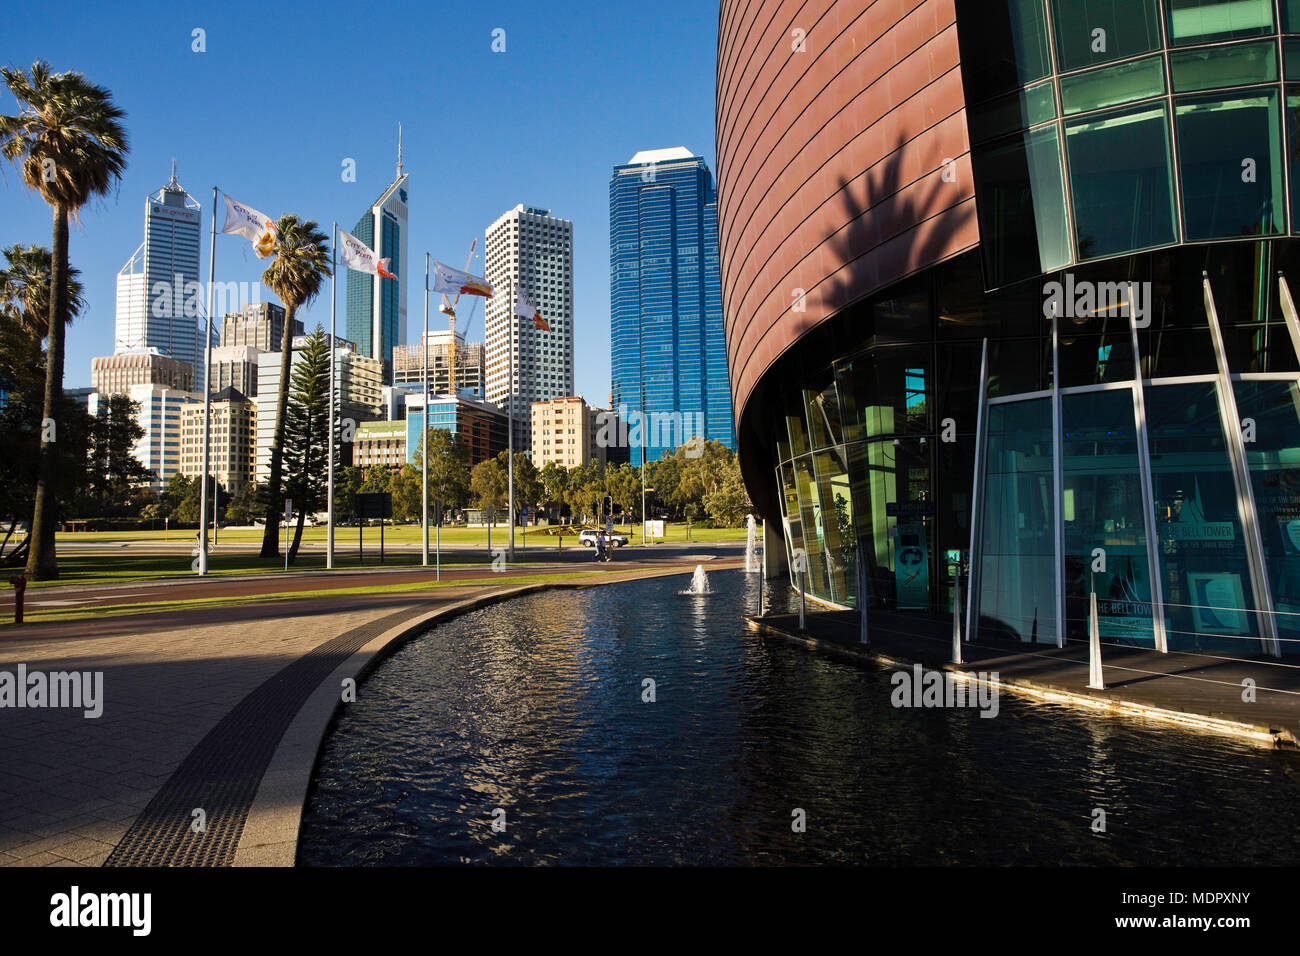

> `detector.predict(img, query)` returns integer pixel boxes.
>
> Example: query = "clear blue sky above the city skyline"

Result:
[0,0,718,403]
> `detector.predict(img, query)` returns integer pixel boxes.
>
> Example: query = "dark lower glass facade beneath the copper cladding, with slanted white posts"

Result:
[759,238,1300,654]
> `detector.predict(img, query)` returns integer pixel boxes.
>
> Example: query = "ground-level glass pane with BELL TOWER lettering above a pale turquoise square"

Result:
[1145,382,1258,653]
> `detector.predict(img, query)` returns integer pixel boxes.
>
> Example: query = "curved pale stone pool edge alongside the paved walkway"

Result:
[233,558,742,866]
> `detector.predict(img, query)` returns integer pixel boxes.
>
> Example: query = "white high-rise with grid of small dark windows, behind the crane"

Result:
[484,204,573,454]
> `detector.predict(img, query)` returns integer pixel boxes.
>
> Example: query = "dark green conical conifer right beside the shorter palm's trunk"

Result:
[283,327,330,564]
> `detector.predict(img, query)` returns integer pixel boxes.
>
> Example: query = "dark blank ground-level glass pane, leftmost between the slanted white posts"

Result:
[976,398,1057,643]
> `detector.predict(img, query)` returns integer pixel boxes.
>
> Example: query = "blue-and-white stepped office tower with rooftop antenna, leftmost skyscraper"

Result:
[113,161,205,394]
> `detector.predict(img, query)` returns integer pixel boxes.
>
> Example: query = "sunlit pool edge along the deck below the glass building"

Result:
[746,617,1300,749]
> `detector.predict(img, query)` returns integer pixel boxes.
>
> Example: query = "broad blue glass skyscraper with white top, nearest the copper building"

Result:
[610,146,736,464]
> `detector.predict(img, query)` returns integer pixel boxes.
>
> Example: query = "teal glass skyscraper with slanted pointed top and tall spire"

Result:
[346,137,411,385]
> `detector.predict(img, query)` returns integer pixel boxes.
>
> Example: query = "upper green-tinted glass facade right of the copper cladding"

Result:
[957,0,1300,289]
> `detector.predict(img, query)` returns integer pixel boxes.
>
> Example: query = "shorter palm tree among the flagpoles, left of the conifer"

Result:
[261,215,334,558]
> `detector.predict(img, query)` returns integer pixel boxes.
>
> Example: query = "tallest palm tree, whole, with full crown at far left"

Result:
[0,60,127,580]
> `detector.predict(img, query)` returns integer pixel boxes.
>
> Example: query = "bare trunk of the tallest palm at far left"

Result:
[27,203,68,581]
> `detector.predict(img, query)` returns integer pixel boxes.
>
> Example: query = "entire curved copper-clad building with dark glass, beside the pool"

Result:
[716,0,1300,654]
